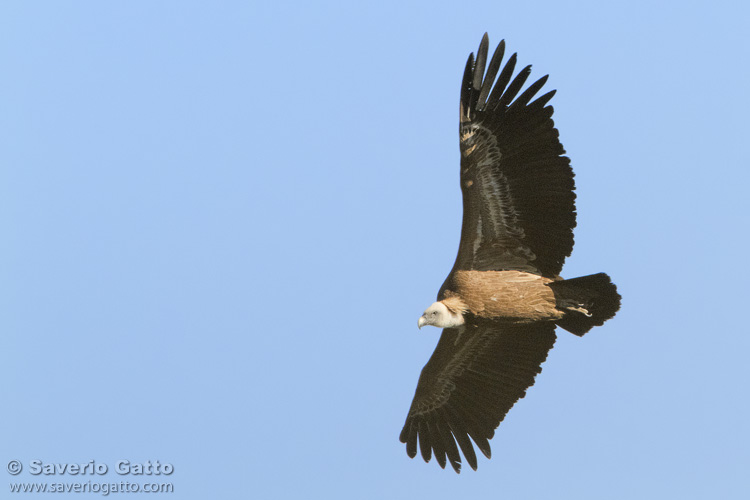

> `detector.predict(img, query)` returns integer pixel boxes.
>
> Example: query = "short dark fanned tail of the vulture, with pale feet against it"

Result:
[549,273,620,336]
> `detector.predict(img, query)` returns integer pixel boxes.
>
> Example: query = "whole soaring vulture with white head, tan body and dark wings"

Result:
[400,34,620,472]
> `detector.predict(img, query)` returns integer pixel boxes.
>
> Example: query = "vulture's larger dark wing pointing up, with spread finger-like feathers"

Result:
[449,34,576,286]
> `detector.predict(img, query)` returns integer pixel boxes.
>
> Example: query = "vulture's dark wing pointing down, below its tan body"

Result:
[400,321,555,472]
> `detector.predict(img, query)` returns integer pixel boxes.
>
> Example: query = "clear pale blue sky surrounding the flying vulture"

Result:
[0,0,750,500]
